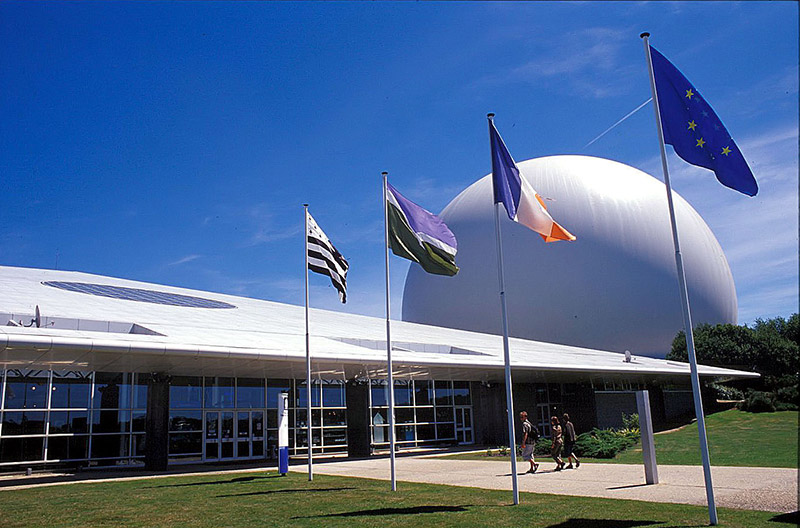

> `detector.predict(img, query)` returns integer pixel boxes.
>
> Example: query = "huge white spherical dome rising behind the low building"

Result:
[403,156,737,357]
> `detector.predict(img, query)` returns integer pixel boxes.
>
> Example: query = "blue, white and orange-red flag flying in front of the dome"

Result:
[489,119,575,242]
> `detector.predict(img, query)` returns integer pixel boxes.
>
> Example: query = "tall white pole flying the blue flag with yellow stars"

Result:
[640,33,718,526]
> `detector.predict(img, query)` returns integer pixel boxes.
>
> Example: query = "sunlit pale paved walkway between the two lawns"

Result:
[291,456,798,513]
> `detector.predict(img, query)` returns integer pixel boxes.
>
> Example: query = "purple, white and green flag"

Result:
[386,182,458,276]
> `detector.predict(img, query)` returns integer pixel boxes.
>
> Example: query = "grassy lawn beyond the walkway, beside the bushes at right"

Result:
[440,409,798,468]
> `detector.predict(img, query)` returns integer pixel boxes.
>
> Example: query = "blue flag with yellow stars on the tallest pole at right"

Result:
[650,46,758,196]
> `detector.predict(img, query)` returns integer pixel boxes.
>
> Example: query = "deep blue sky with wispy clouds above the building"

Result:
[0,1,798,323]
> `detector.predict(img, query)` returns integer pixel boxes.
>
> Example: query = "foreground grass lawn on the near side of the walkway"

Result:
[0,472,796,528]
